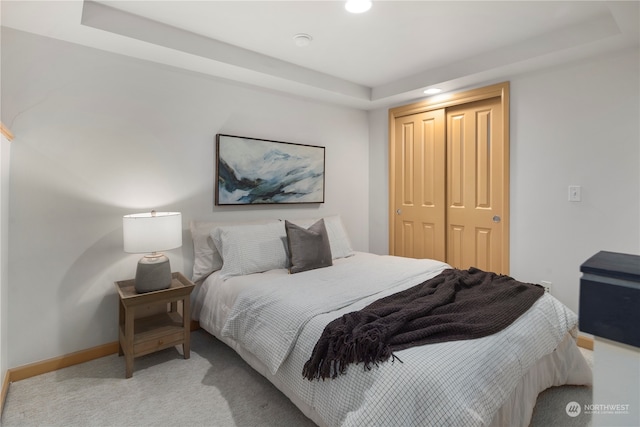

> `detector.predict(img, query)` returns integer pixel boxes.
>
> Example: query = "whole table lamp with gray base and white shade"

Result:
[122,211,182,293]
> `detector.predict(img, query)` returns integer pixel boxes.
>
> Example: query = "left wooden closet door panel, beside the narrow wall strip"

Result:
[392,110,446,261]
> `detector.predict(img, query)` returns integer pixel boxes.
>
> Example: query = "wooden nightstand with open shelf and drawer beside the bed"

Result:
[115,273,194,378]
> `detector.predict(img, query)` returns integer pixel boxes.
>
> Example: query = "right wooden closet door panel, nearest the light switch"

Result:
[446,98,508,273]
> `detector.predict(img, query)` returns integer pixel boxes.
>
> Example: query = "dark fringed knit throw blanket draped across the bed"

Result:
[302,267,544,380]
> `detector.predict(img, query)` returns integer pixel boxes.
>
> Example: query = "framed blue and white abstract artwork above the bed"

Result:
[215,134,325,205]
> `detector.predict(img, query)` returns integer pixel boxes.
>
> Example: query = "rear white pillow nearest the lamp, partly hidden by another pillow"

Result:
[189,219,279,282]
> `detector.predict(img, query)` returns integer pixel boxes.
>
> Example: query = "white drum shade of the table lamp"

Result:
[122,212,182,254]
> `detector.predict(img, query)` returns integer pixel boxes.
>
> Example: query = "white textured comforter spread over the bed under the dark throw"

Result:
[194,253,577,426]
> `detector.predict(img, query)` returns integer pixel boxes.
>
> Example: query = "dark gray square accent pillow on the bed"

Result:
[284,219,333,274]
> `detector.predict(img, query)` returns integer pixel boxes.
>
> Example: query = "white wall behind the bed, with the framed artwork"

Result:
[2,28,369,367]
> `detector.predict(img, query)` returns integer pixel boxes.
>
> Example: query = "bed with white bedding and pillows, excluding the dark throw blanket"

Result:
[191,216,592,426]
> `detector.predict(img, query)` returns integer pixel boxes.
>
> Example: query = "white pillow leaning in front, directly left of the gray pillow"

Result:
[211,221,289,277]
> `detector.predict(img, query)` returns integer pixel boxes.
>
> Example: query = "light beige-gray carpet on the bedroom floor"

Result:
[2,331,591,427]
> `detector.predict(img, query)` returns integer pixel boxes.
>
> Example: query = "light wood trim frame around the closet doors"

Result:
[388,81,511,274]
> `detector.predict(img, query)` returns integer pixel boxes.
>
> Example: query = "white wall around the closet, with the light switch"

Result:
[369,49,640,312]
